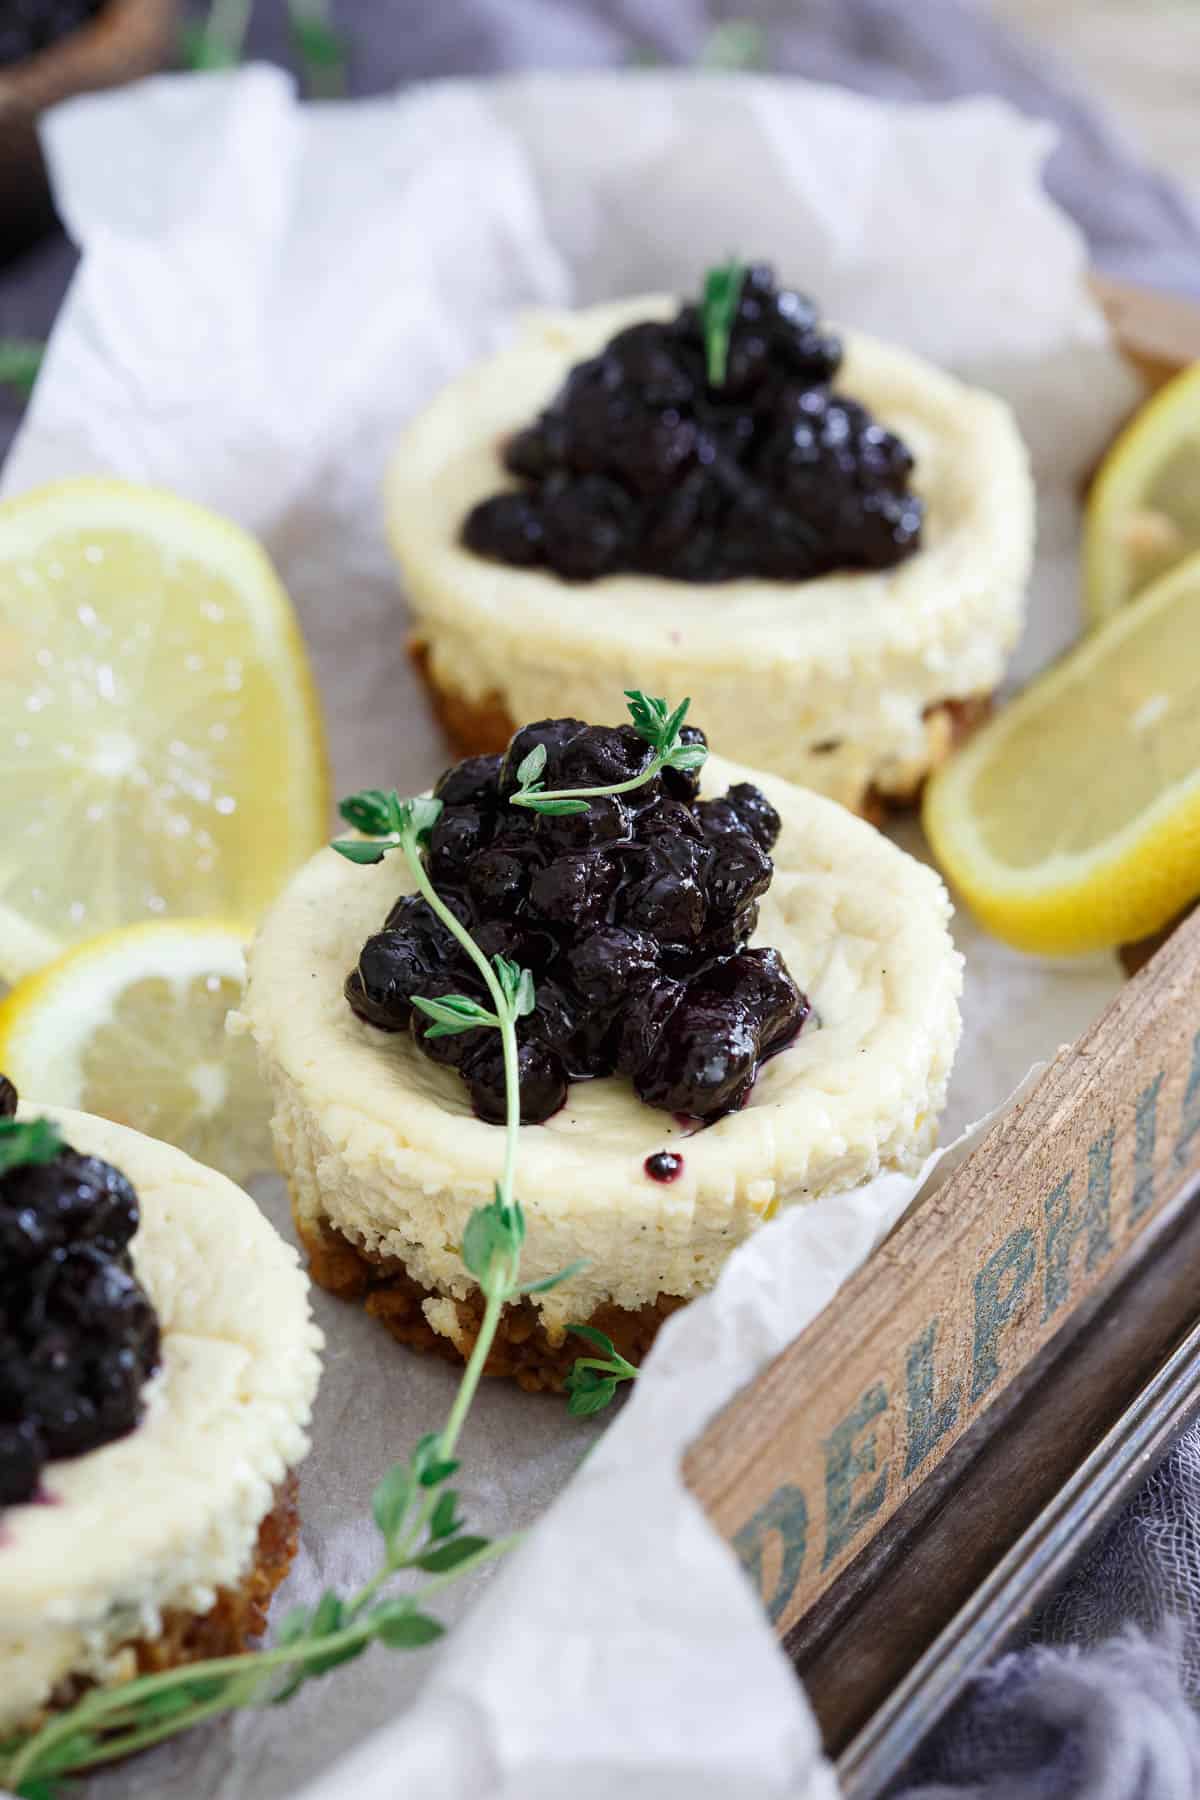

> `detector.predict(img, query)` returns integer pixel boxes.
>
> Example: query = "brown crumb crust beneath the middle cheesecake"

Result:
[295,1217,685,1393]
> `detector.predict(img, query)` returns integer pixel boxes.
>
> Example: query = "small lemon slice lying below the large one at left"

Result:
[0,920,273,1183]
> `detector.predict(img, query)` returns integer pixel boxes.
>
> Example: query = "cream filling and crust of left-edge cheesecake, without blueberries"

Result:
[0,1107,322,1732]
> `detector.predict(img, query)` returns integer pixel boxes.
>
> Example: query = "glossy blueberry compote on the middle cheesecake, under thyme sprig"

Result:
[345,718,808,1125]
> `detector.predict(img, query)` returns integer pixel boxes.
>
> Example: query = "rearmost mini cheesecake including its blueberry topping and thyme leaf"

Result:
[387,265,1033,810]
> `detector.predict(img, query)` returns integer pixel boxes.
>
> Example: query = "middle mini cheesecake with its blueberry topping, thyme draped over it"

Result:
[245,718,961,1388]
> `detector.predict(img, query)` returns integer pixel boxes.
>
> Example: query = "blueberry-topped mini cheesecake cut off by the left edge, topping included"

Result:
[0,1082,320,1730]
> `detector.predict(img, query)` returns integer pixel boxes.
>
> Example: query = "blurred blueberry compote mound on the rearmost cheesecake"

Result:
[462,265,925,581]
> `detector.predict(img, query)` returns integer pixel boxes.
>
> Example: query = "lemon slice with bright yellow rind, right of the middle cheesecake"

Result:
[923,556,1200,952]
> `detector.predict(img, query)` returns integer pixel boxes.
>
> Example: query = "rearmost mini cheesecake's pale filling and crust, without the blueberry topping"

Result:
[387,282,1033,814]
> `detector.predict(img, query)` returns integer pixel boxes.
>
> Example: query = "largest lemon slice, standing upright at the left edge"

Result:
[0,481,327,981]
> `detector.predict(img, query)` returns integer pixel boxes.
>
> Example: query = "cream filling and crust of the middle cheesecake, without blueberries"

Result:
[243,745,963,1388]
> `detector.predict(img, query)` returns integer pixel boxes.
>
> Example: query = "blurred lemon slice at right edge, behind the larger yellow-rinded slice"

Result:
[1083,364,1200,625]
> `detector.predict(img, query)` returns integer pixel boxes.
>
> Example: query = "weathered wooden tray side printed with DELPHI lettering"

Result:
[685,916,1200,1633]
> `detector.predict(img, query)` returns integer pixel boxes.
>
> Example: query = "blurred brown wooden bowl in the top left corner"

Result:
[0,0,176,261]
